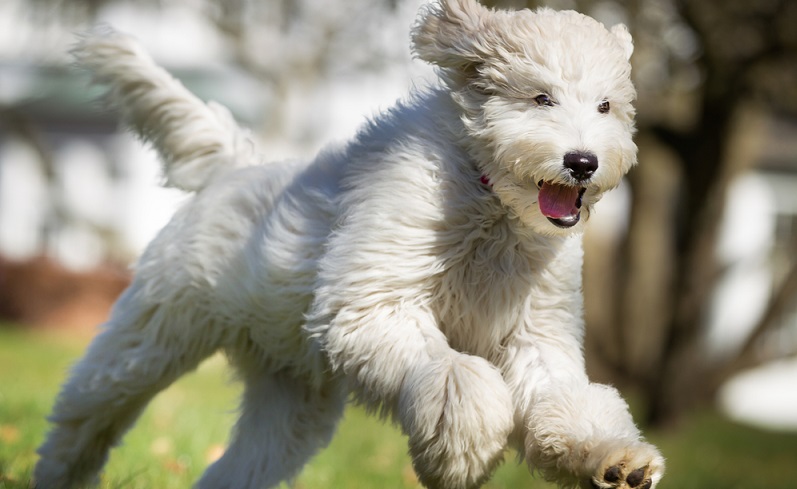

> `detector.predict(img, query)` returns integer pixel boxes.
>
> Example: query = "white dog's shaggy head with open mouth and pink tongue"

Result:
[413,0,637,235]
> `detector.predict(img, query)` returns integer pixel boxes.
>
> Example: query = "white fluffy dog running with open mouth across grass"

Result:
[34,0,664,489]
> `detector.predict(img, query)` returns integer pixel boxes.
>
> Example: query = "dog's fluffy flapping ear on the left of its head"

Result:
[412,0,494,71]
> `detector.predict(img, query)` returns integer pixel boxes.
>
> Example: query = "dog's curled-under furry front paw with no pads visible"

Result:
[398,354,513,489]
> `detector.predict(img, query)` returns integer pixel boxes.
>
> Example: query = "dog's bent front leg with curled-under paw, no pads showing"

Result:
[308,300,512,489]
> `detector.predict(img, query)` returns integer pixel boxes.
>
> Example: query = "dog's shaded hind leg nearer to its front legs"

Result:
[197,359,347,489]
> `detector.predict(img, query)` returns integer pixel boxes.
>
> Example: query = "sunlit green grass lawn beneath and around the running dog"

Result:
[0,328,797,489]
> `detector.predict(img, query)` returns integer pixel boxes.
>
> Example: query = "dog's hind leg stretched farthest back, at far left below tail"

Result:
[34,287,221,489]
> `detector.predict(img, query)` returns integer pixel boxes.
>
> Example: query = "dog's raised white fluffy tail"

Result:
[73,27,258,191]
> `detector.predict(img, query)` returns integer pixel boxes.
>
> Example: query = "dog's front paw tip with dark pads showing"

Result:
[582,442,664,489]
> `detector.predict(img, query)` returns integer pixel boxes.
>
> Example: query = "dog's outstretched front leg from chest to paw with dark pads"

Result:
[497,234,664,489]
